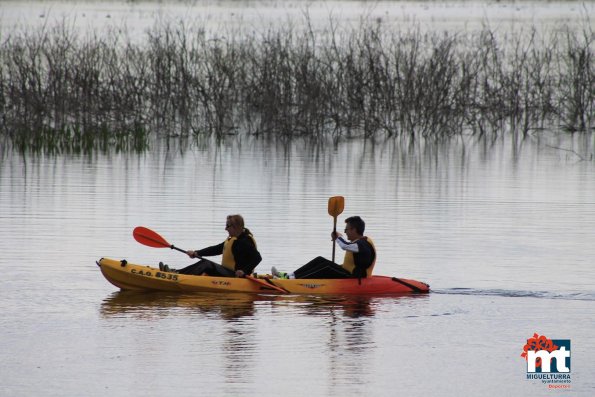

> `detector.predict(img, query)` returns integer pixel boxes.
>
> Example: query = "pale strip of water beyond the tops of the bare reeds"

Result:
[0,0,595,40]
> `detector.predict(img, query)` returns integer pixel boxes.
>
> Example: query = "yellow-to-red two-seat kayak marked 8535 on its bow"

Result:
[97,258,430,295]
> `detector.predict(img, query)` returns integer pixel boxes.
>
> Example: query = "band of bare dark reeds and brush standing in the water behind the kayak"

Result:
[0,16,595,152]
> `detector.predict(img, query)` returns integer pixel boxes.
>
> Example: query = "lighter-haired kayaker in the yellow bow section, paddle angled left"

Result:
[159,215,262,277]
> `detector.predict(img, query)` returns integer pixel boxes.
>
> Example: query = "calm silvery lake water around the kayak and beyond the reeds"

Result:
[0,2,595,397]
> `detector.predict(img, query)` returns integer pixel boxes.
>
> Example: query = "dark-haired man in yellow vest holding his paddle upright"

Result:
[271,216,376,279]
